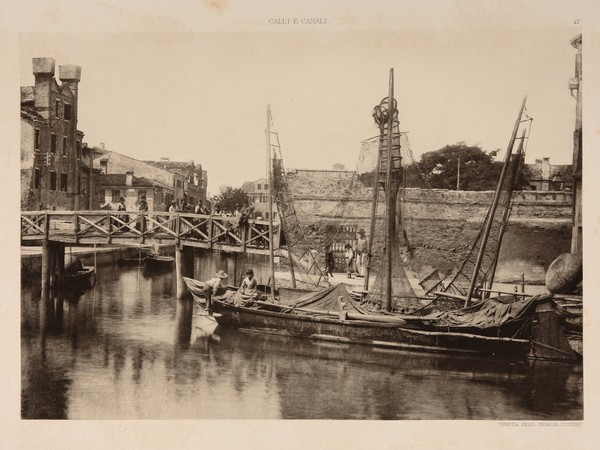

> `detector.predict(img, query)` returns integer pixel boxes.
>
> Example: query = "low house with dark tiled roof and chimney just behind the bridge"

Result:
[98,170,173,211]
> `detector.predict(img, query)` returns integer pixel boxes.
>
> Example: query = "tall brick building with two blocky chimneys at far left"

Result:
[21,58,98,211]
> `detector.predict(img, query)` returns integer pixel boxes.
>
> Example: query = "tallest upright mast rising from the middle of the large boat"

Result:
[384,68,396,311]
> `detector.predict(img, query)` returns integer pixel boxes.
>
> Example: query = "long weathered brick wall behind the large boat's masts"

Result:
[288,170,572,283]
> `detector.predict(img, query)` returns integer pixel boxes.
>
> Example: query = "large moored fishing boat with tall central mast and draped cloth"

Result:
[196,69,577,361]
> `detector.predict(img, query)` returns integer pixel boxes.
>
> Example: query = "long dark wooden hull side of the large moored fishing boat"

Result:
[212,300,531,359]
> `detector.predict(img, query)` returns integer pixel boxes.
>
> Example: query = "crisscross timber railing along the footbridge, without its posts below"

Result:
[21,211,280,253]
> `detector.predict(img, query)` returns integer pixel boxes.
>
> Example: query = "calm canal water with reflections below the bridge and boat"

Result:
[21,267,583,420]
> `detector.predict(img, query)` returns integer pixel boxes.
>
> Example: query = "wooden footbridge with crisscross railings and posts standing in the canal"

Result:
[21,211,281,299]
